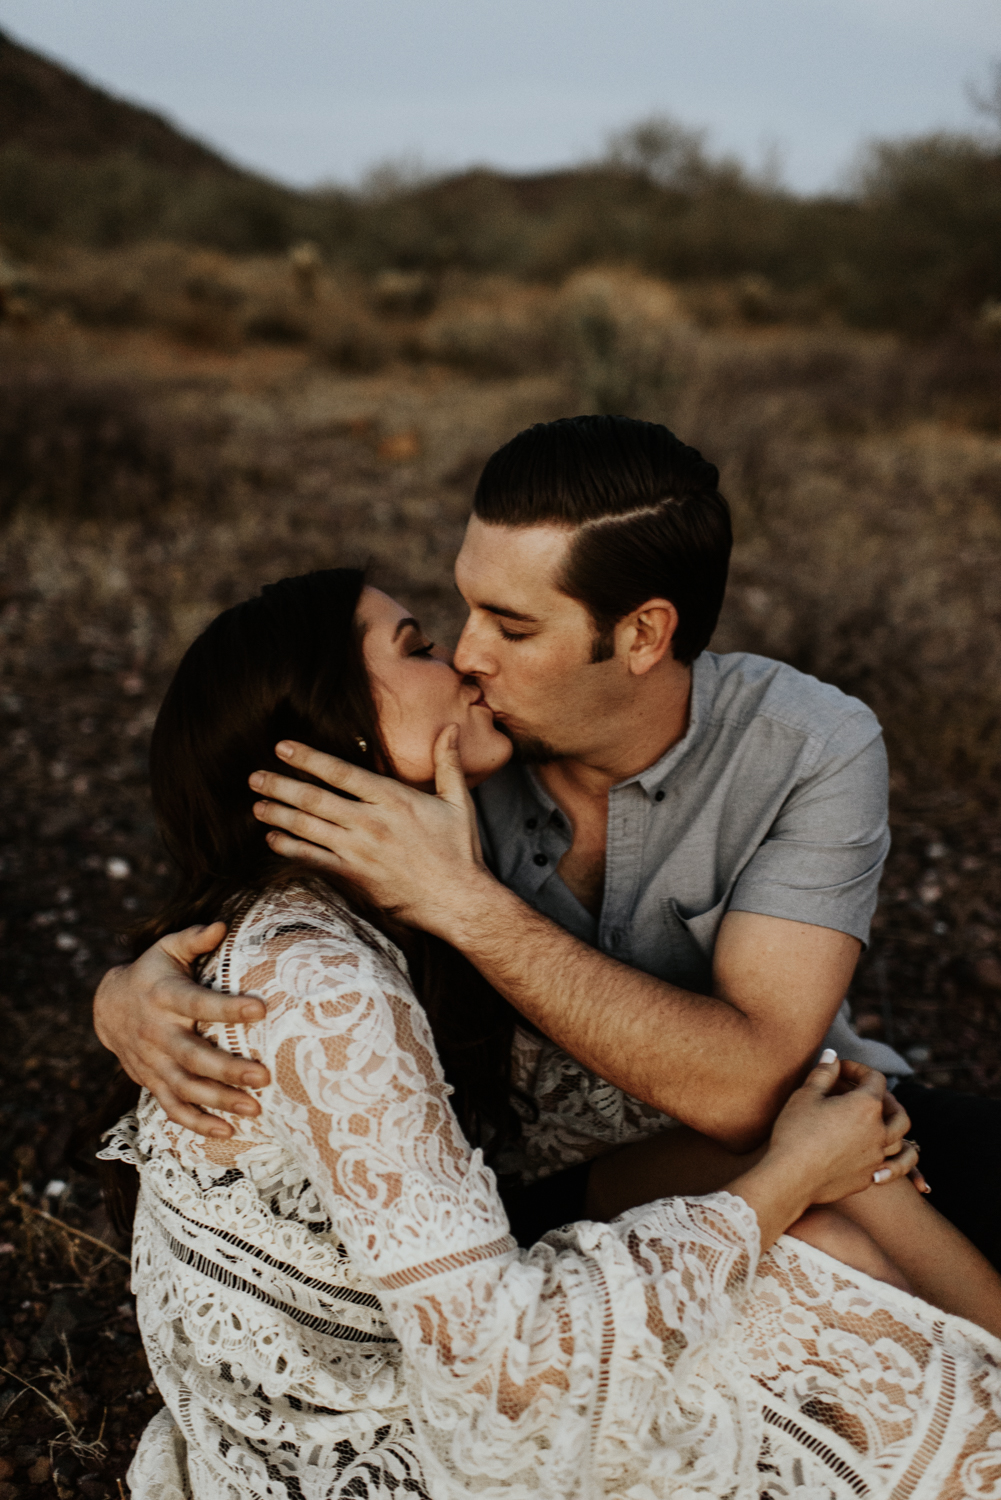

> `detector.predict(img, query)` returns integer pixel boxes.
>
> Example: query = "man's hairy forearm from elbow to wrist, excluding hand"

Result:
[435,876,798,1151]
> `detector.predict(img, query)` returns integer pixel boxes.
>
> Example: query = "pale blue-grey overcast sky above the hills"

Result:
[0,0,1001,191]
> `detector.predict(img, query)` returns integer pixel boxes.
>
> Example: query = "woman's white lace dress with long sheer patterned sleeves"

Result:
[108,890,1001,1500]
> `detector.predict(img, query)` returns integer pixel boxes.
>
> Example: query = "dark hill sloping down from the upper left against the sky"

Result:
[0,32,243,177]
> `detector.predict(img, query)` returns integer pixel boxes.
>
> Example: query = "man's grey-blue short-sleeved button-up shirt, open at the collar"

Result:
[476,651,911,1074]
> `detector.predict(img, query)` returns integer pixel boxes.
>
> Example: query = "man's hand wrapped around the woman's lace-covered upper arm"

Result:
[95,923,270,1140]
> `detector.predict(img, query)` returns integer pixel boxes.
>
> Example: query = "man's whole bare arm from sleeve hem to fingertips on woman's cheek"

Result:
[244,731,861,1149]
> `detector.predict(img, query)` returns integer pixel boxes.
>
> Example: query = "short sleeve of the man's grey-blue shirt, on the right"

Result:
[729,710,890,944]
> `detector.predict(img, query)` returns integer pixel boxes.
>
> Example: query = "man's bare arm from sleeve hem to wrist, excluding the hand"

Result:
[405,875,861,1151]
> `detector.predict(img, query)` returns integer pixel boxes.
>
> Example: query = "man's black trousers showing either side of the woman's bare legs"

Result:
[504,1079,1001,1271]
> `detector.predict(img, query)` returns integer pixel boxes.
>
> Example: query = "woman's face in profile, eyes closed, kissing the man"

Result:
[357,588,512,788]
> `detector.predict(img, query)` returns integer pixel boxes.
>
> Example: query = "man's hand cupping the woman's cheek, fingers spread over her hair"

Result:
[251,725,495,936]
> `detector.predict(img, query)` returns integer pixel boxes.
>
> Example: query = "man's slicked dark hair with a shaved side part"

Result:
[473,417,732,665]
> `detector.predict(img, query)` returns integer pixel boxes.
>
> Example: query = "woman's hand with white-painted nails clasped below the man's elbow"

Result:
[729,1055,917,1250]
